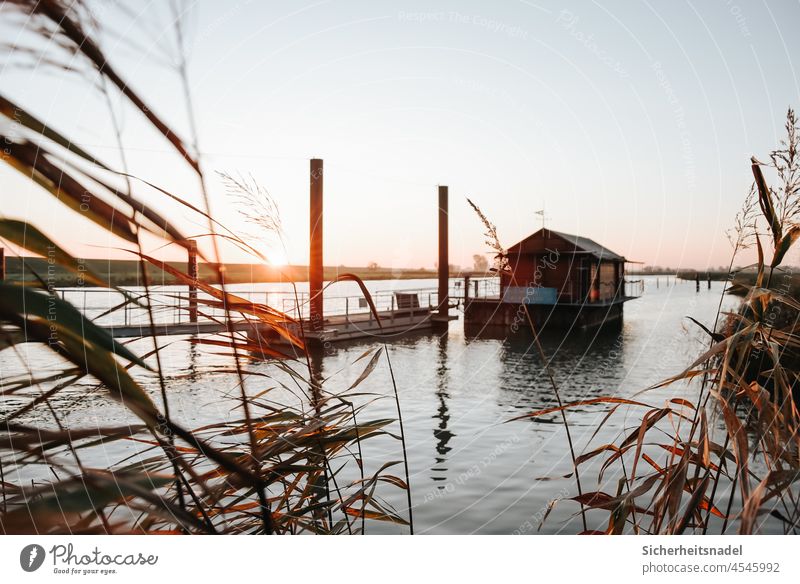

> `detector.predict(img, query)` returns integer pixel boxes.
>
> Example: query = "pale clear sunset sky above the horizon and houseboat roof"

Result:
[0,0,800,268]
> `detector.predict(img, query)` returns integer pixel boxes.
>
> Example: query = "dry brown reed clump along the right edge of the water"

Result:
[515,109,800,534]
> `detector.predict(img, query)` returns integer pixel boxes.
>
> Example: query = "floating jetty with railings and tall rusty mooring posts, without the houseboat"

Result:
[37,159,462,344]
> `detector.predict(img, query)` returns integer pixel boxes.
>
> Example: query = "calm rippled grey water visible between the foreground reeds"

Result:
[0,277,752,533]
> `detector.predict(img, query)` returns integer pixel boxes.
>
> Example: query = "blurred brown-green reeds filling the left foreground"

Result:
[0,0,413,534]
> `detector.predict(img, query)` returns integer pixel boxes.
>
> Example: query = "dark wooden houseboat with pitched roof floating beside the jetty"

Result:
[465,228,630,329]
